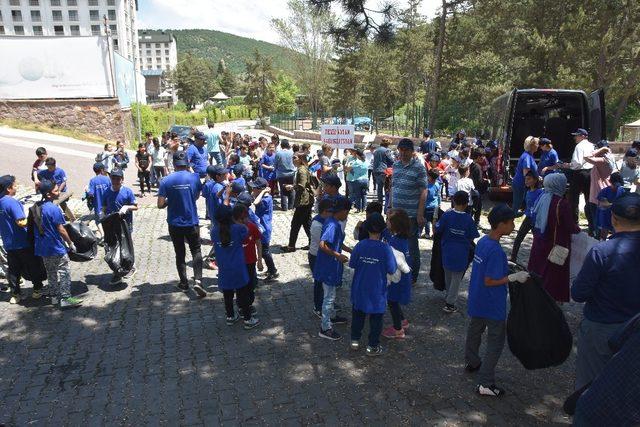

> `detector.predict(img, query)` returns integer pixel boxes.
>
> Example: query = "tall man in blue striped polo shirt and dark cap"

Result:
[389,138,427,283]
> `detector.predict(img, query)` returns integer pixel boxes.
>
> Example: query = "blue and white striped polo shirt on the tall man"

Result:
[391,157,427,218]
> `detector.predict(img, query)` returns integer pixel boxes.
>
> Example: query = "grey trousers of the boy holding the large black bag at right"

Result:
[464,317,506,386]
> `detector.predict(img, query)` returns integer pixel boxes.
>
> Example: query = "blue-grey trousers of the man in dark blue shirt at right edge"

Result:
[575,319,622,390]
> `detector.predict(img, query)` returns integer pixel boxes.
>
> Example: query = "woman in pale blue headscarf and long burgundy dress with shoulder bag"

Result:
[528,173,580,302]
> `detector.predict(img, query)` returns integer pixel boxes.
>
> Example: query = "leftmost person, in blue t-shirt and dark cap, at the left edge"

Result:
[0,175,46,304]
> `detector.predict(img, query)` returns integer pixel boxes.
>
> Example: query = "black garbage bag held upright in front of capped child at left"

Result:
[100,212,135,275]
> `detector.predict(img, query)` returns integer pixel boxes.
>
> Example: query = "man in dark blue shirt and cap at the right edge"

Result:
[571,193,640,390]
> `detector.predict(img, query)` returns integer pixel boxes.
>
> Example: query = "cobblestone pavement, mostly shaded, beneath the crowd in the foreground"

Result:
[0,195,580,425]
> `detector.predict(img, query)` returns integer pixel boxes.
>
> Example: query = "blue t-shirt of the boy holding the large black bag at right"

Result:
[467,236,509,320]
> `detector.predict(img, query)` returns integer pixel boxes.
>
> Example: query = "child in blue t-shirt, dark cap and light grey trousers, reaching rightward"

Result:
[313,198,351,341]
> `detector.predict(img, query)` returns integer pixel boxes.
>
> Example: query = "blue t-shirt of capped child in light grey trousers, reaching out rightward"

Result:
[313,217,344,286]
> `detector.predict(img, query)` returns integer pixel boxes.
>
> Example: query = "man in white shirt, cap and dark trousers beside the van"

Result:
[563,128,596,234]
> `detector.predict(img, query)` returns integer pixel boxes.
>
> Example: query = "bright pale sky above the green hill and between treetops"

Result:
[138,0,441,43]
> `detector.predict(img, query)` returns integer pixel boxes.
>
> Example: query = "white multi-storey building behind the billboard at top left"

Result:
[0,0,140,69]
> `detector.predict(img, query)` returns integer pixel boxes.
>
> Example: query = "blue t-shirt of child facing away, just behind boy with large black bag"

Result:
[436,209,480,271]
